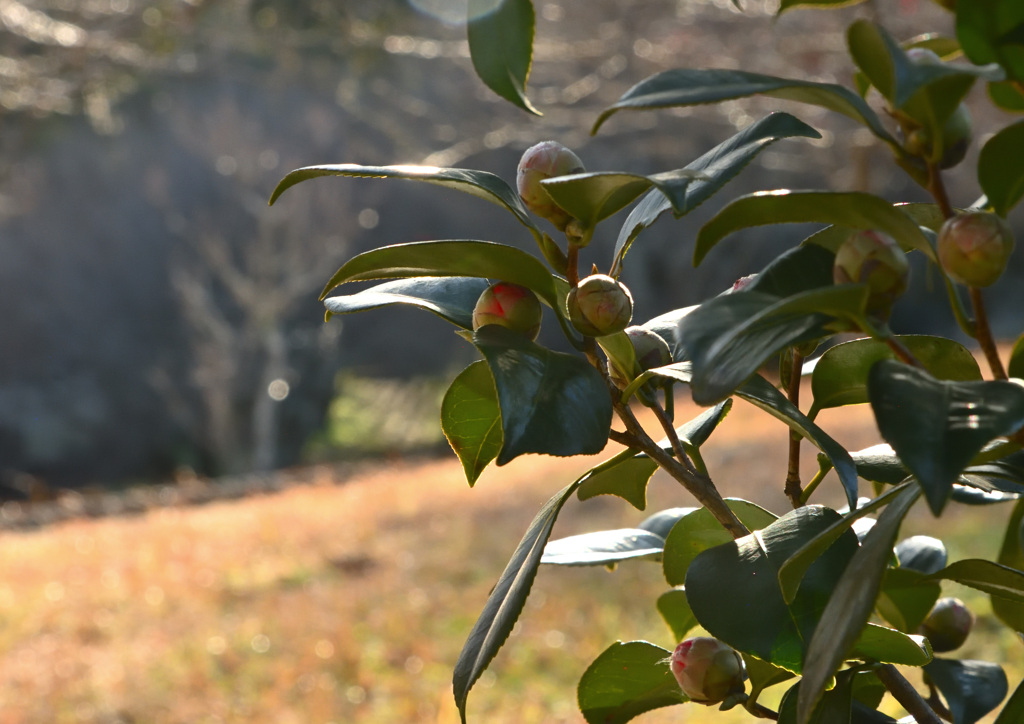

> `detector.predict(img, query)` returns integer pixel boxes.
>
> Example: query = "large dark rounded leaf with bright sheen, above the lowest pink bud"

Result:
[684,506,857,672]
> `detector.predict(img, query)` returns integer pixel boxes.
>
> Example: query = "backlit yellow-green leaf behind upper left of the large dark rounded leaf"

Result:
[662,498,776,586]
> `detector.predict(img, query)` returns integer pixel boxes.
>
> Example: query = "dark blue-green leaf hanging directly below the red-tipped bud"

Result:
[473,325,612,465]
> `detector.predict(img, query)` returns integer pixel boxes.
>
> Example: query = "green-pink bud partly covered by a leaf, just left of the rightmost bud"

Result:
[833,229,910,320]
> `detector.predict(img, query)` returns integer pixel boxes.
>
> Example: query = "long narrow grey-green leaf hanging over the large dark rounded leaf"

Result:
[798,487,921,722]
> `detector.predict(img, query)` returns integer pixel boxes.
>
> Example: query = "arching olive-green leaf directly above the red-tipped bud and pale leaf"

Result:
[321,241,561,310]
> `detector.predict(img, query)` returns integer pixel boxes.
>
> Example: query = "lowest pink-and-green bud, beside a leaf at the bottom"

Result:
[670,636,746,705]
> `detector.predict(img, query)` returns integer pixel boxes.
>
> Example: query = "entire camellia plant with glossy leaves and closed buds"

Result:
[270,0,1024,724]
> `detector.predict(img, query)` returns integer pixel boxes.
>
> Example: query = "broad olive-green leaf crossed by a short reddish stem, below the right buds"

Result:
[809,335,982,418]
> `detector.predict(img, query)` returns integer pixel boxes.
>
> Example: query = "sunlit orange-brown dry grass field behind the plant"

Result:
[0,391,1024,724]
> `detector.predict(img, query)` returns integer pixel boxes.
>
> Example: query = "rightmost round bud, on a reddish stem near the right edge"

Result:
[938,211,1014,287]
